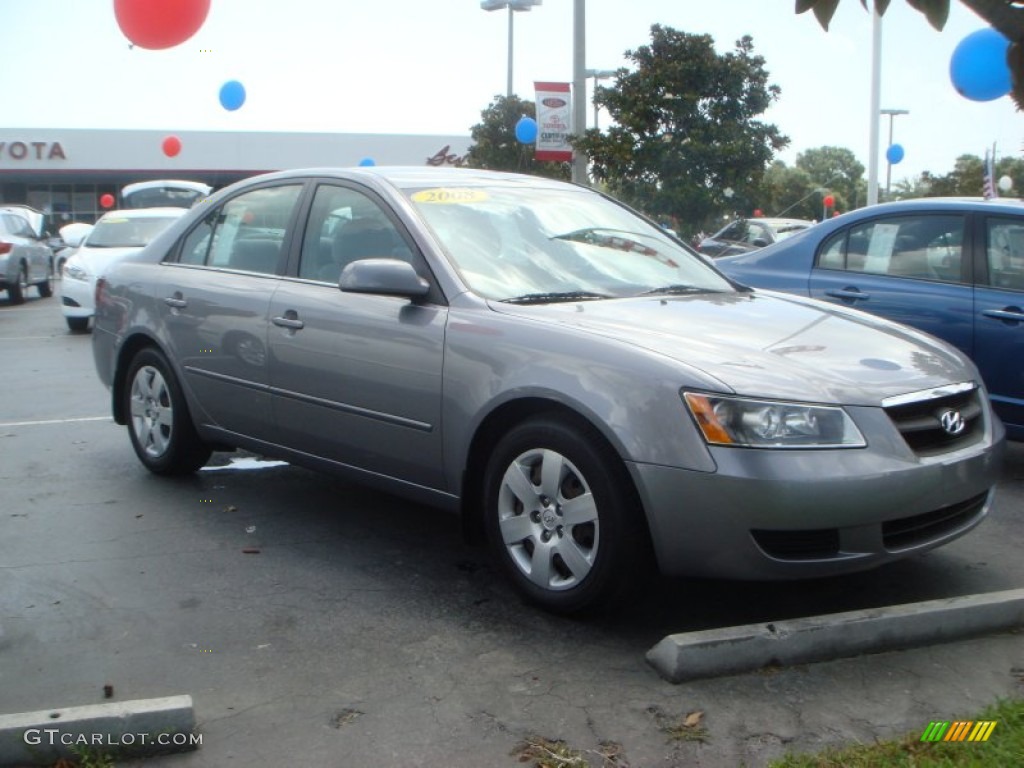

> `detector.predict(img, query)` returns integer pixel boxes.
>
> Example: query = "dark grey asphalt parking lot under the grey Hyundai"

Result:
[0,292,1024,768]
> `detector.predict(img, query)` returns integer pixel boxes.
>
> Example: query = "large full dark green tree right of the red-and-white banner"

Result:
[573,25,788,229]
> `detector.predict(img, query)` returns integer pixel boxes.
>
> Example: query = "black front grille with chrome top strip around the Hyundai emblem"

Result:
[883,384,984,456]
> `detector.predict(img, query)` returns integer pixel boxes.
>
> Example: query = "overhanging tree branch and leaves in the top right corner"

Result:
[797,0,1024,110]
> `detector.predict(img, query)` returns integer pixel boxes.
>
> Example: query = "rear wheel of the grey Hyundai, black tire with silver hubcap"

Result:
[124,347,213,475]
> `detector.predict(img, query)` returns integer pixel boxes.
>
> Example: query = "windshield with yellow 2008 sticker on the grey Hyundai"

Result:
[406,185,733,303]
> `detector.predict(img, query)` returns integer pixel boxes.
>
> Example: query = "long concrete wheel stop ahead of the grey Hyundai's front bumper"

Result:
[647,589,1024,683]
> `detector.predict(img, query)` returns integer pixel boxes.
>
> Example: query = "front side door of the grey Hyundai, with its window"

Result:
[267,183,447,488]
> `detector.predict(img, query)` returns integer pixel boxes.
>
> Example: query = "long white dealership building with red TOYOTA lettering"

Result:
[0,128,470,224]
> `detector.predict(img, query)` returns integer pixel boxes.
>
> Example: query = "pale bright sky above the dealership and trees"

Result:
[0,0,1024,184]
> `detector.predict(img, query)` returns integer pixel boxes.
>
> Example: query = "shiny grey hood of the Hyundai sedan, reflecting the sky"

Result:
[492,292,978,406]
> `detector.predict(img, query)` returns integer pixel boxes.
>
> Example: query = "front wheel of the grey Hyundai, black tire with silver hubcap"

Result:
[483,416,651,614]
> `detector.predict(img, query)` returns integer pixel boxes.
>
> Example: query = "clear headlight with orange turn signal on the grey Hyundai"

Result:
[682,392,867,449]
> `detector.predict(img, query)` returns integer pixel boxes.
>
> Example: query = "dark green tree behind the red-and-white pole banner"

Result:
[466,95,571,180]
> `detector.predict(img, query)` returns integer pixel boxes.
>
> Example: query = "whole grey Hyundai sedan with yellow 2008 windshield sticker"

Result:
[93,167,1004,612]
